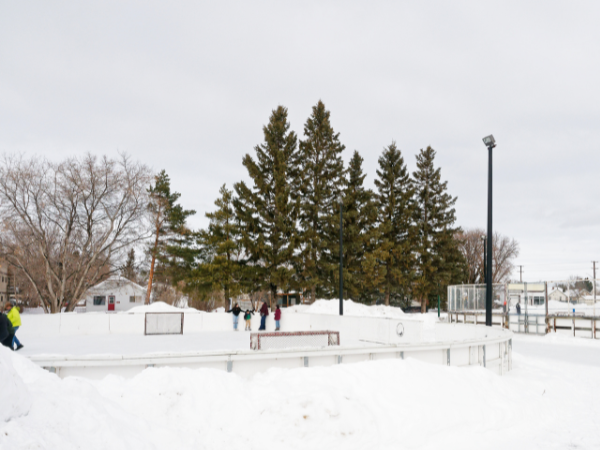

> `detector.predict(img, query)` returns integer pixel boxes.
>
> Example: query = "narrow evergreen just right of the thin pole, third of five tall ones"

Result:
[334,151,377,301]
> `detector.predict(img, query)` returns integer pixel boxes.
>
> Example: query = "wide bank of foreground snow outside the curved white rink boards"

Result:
[0,336,600,450]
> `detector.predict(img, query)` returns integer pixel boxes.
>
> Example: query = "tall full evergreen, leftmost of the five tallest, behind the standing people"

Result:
[235,106,298,301]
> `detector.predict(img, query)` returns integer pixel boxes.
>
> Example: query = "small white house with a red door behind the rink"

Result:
[85,276,146,312]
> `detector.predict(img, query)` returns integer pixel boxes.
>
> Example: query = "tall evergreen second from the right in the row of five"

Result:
[366,142,414,305]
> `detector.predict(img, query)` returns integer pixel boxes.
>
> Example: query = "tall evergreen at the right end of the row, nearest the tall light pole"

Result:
[413,147,463,312]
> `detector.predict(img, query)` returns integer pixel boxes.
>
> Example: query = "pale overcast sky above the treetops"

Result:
[0,0,600,281]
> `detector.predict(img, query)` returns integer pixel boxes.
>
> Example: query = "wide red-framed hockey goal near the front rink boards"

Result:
[250,331,340,350]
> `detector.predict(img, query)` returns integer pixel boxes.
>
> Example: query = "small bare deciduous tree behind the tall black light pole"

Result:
[458,228,519,284]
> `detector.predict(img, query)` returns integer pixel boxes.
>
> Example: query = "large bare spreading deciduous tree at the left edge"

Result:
[0,154,151,313]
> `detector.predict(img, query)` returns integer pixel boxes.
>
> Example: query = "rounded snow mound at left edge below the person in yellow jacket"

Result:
[0,345,31,423]
